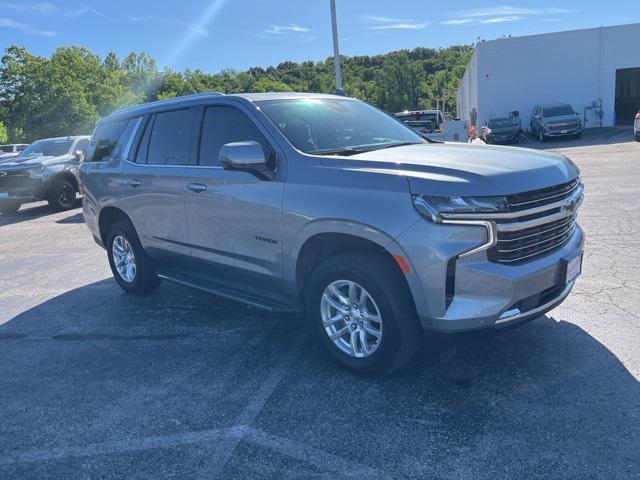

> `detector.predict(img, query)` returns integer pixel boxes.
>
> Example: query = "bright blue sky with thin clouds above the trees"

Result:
[0,0,640,72]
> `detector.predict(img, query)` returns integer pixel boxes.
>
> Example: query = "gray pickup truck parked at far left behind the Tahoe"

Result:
[0,136,89,214]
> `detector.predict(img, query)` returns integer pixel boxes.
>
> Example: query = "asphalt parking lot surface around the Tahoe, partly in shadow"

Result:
[0,133,640,479]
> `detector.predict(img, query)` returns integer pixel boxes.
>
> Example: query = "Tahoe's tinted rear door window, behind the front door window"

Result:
[143,110,194,165]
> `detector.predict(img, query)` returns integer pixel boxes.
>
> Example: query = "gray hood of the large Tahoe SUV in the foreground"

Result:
[323,143,579,196]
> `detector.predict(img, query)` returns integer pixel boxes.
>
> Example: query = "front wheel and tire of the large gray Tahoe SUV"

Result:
[306,252,422,376]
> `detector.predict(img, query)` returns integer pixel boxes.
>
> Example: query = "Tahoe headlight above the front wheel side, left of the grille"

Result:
[413,195,509,223]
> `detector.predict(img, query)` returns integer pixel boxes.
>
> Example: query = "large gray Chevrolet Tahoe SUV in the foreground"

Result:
[81,93,583,374]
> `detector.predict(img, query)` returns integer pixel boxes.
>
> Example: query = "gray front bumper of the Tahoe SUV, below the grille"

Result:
[397,222,584,333]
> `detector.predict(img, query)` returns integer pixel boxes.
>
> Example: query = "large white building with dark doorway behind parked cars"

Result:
[458,23,640,130]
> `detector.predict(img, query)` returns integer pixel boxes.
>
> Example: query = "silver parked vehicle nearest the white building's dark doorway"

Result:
[530,103,582,142]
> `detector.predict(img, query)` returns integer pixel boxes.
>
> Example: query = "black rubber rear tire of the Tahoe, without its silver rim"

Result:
[106,220,162,294]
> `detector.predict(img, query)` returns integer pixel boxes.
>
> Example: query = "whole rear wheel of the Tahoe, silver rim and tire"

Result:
[106,220,161,293]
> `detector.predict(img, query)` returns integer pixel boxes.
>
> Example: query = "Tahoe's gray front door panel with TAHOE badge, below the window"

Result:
[185,167,284,290]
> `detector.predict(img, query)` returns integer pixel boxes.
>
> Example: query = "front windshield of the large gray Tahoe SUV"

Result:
[256,98,425,154]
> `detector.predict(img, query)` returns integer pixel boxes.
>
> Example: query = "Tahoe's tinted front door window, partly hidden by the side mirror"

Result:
[200,107,273,166]
